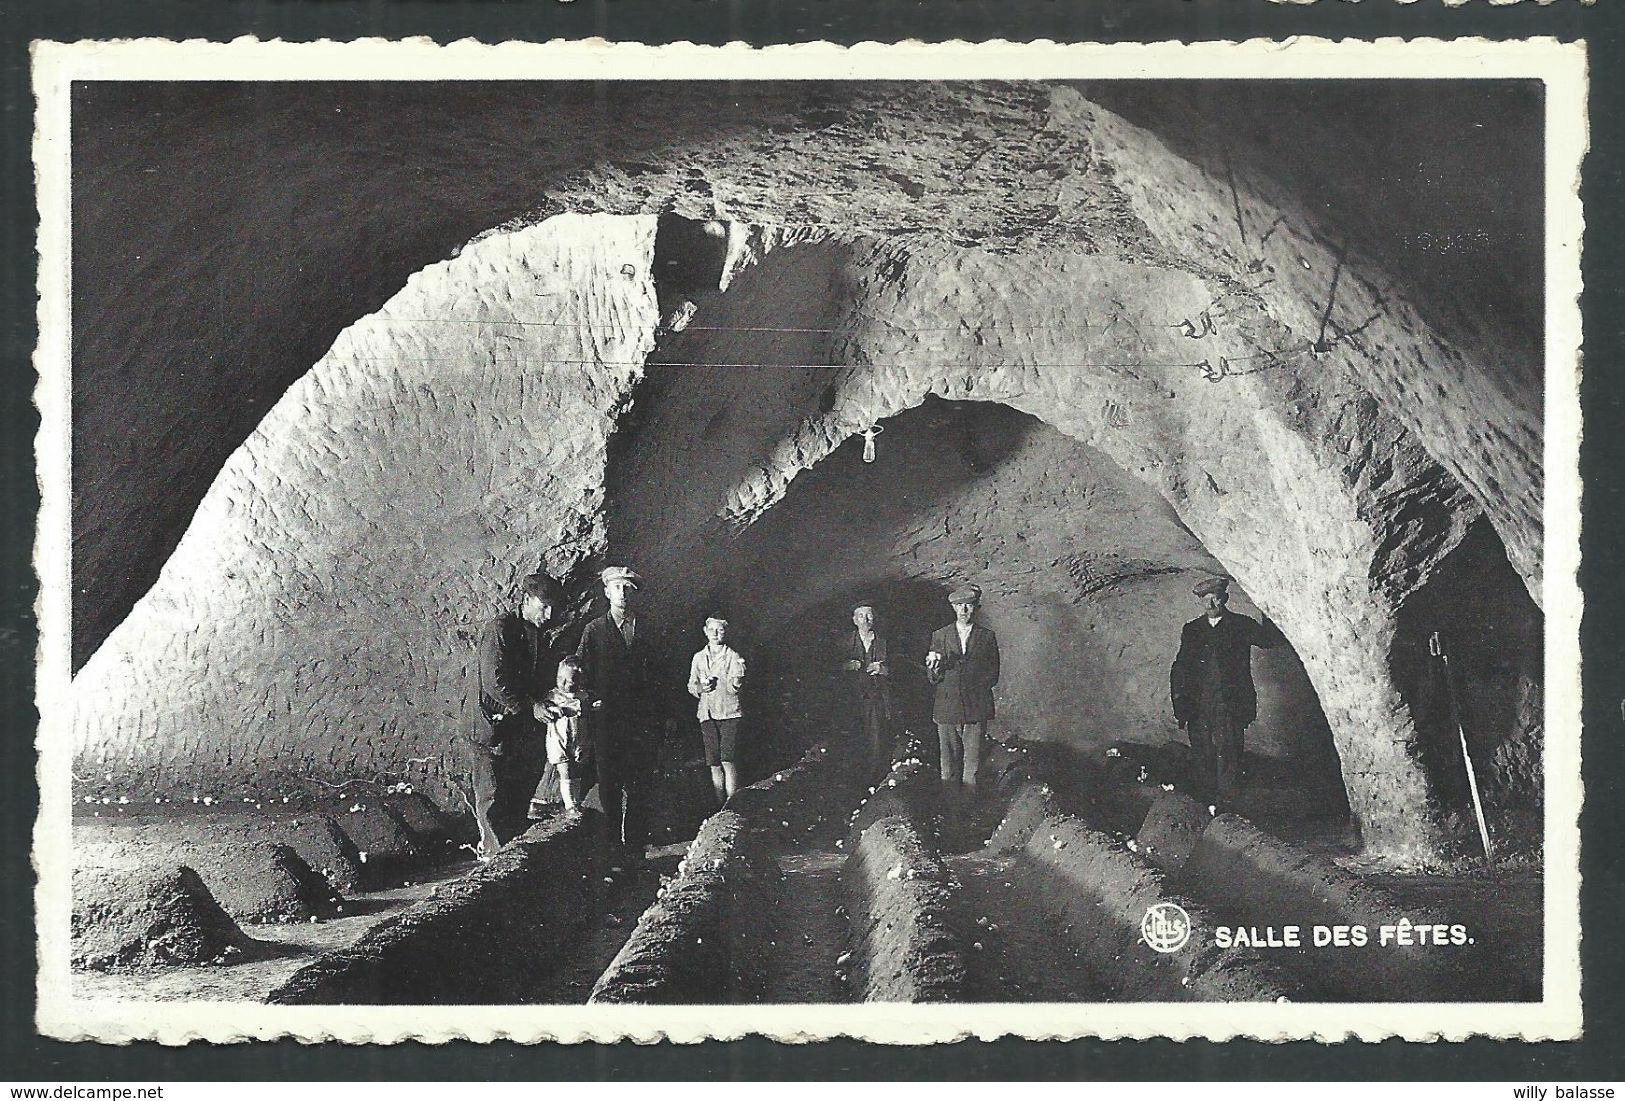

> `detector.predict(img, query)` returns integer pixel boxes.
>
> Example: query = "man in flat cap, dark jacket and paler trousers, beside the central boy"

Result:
[925,585,999,809]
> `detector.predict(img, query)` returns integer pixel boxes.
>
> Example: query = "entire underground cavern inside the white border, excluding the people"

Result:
[72,83,1545,1005]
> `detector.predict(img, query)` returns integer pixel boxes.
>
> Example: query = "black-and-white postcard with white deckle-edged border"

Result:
[34,39,1586,1044]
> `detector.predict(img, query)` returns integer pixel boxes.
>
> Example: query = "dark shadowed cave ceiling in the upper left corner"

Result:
[70,81,884,671]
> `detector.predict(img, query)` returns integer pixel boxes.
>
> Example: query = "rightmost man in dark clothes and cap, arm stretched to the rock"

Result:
[1168,576,1282,802]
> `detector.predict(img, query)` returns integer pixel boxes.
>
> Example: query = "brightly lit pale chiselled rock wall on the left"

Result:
[75,214,658,805]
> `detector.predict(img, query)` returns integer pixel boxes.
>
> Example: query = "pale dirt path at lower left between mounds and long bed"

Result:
[73,861,475,1002]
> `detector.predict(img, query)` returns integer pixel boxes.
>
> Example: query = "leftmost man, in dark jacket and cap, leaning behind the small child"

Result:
[470,573,564,856]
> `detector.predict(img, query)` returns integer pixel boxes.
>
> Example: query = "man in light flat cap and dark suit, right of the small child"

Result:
[575,565,658,857]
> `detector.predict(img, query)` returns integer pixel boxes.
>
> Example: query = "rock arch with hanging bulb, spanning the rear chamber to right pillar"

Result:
[611,231,1479,859]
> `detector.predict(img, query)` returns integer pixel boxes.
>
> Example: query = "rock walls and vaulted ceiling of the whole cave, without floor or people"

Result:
[73,83,1544,862]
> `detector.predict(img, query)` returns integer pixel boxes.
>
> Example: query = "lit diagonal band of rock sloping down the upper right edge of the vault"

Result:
[1066,97,1544,604]
